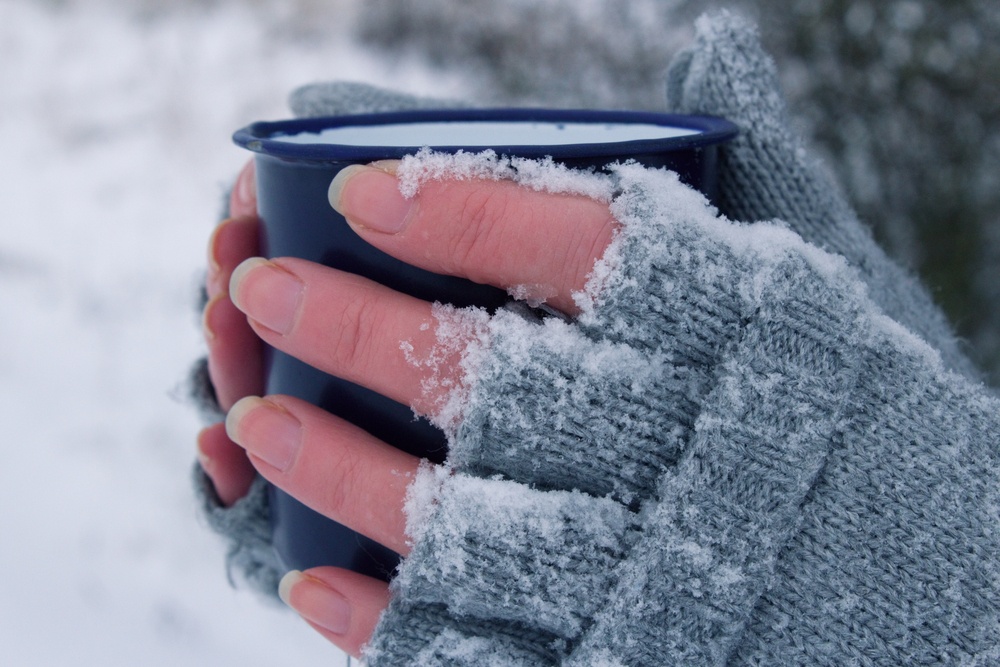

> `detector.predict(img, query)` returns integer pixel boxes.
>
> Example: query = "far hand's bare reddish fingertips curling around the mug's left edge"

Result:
[198,162,263,507]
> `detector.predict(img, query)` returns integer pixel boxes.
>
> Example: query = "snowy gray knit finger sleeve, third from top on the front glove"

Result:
[395,471,634,638]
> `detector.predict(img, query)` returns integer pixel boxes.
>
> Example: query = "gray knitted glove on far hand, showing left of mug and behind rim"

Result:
[189,82,460,600]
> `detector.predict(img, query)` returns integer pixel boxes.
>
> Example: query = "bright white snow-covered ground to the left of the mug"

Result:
[0,0,464,667]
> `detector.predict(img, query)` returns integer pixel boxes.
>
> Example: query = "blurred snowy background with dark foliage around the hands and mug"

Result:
[0,0,1000,666]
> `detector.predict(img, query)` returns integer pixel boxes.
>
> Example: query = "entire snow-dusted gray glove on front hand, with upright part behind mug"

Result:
[367,11,1000,667]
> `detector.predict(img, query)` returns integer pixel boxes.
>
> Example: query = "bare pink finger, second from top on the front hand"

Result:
[230,258,462,414]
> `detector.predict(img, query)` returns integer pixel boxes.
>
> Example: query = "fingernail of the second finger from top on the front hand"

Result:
[229,257,304,335]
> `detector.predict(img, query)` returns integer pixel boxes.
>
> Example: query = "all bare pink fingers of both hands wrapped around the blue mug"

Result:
[198,155,617,655]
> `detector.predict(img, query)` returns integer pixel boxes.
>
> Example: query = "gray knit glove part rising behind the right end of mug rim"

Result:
[667,12,977,377]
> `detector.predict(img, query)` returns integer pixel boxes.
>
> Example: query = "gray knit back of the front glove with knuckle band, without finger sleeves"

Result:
[567,164,1000,665]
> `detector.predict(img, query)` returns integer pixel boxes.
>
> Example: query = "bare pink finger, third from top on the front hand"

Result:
[226,396,420,555]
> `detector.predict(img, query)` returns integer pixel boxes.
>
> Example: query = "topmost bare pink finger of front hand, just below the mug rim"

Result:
[330,163,617,314]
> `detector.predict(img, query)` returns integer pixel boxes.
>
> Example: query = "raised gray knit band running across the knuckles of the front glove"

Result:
[572,233,865,665]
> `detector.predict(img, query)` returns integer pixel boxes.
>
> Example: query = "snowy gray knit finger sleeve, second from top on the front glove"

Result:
[449,313,705,504]
